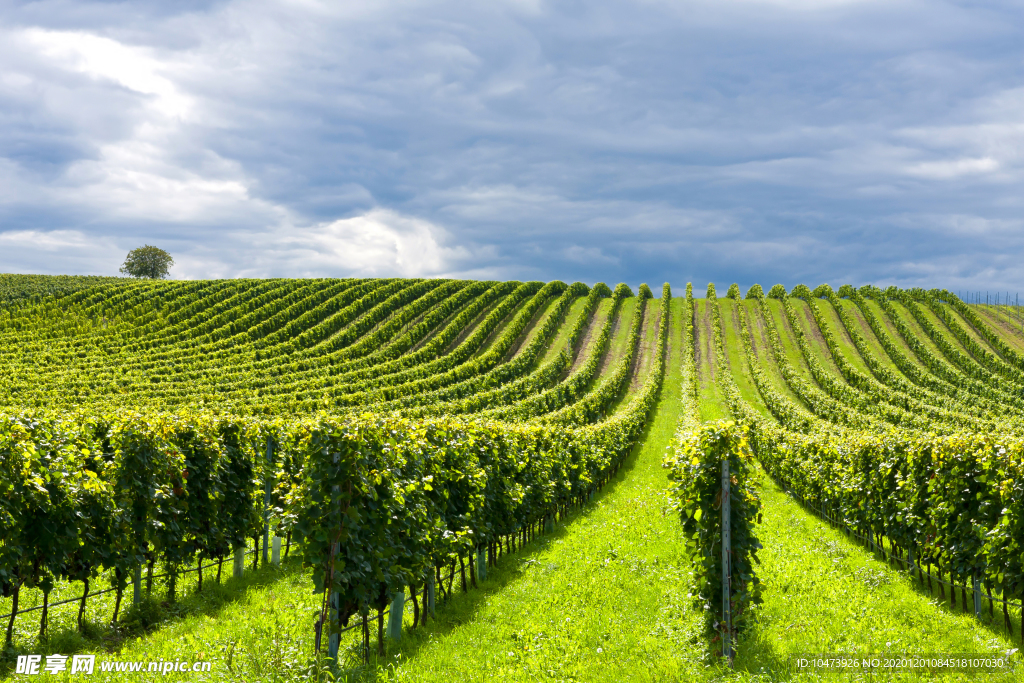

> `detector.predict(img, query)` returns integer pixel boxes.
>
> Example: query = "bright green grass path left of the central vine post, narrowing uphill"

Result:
[379,290,703,681]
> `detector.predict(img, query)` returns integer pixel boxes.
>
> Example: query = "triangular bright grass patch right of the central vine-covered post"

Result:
[737,477,1020,681]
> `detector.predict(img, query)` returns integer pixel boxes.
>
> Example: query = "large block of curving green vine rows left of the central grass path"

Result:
[0,279,671,651]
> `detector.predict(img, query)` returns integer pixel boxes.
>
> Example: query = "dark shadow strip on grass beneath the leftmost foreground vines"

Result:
[0,547,302,679]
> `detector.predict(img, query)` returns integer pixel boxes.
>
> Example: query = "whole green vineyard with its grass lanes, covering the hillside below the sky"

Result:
[0,275,1024,681]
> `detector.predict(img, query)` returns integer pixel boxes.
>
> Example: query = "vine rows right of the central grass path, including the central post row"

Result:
[666,285,1024,659]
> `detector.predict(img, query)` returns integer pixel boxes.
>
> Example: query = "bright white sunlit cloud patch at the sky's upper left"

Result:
[8,28,292,235]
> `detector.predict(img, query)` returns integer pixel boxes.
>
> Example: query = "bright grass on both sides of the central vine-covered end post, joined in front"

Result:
[366,299,1014,681]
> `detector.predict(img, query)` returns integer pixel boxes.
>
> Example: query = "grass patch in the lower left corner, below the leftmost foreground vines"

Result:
[0,547,319,681]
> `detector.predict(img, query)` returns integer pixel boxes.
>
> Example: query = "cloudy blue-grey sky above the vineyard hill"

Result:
[0,0,1024,293]
